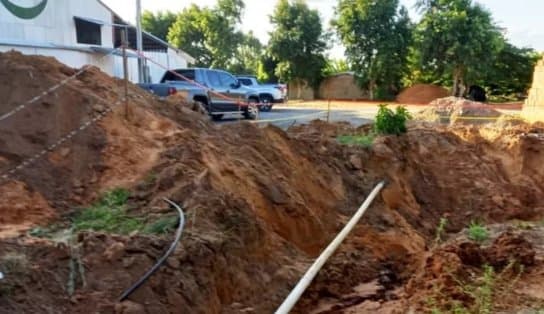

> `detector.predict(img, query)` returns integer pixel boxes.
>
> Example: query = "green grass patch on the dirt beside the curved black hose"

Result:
[73,189,144,234]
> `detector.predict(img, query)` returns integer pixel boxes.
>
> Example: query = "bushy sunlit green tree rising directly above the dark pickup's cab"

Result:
[168,0,244,69]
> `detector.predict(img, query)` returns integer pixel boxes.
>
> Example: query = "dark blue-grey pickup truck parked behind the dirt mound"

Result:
[138,68,261,120]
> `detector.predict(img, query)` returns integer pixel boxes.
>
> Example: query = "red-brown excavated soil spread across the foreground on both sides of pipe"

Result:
[0,53,544,313]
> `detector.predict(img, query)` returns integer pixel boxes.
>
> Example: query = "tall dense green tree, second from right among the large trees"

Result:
[332,0,412,99]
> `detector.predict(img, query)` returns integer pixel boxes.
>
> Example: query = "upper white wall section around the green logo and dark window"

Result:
[0,0,113,48]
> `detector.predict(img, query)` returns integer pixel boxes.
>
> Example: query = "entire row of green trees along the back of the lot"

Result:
[142,0,541,101]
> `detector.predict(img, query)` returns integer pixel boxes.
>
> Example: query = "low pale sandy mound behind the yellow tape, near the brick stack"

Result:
[416,97,501,124]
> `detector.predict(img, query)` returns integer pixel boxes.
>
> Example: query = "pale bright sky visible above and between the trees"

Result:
[103,0,544,58]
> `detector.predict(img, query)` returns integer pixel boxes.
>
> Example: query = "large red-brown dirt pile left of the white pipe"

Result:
[0,53,374,313]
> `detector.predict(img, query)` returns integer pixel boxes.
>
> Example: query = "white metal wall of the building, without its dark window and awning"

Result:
[0,0,191,82]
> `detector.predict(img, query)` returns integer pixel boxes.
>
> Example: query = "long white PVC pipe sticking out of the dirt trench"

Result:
[275,181,385,314]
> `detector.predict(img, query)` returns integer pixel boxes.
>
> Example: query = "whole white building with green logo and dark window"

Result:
[0,0,194,82]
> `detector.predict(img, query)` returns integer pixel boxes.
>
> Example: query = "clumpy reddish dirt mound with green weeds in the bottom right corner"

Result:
[404,224,544,313]
